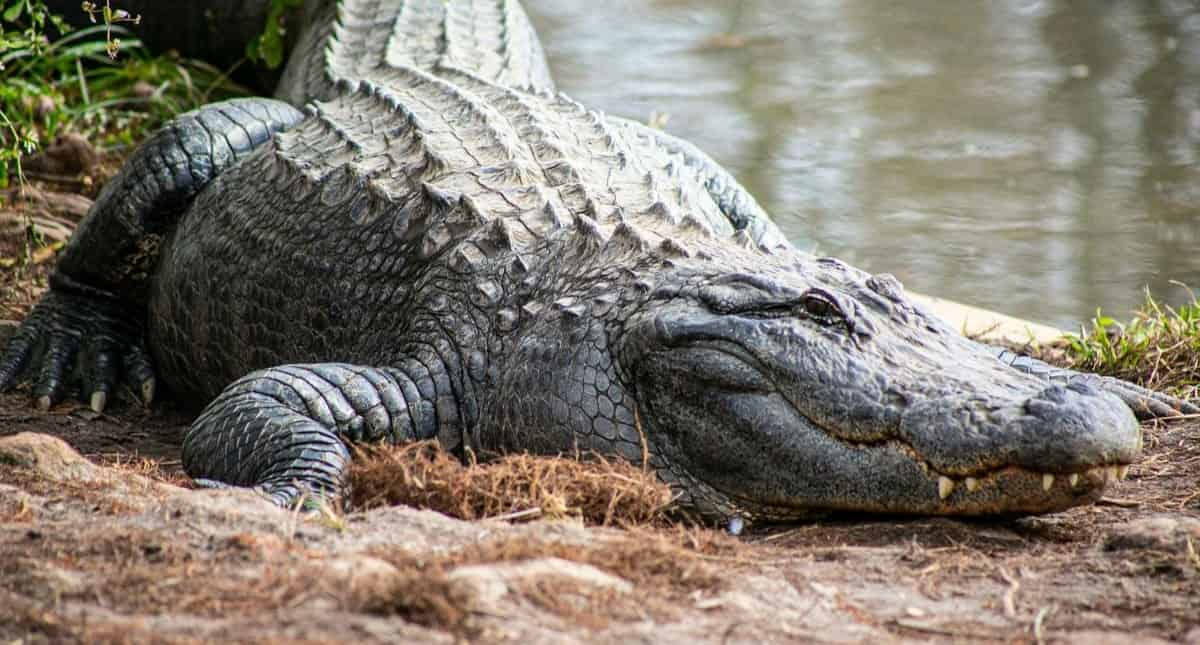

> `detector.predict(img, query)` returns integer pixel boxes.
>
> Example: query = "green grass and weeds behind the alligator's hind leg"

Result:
[0,0,248,188]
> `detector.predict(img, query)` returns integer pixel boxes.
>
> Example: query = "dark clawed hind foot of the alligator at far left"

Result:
[0,276,155,412]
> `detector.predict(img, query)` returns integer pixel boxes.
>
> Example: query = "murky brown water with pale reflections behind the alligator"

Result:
[526,0,1200,326]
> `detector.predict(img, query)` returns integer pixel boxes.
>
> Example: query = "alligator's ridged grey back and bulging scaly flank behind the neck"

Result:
[150,0,733,399]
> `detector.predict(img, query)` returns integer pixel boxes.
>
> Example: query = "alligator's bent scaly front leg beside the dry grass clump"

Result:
[184,361,461,506]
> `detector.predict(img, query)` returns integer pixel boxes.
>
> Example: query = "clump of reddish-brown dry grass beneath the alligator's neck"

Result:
[349,442,671,526]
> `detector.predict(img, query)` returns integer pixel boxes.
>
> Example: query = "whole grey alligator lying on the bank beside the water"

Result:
[0,0,1198,523]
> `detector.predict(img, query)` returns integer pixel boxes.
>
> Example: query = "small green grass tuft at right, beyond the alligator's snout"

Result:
[1066,290,1200,398]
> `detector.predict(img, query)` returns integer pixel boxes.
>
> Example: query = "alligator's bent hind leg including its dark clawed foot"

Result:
[0,98,304,411]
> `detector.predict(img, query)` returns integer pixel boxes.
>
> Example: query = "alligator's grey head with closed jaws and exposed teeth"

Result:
[614,251,1141,519]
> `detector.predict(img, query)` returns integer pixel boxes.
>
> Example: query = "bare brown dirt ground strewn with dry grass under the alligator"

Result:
[0,161,1200,643]
